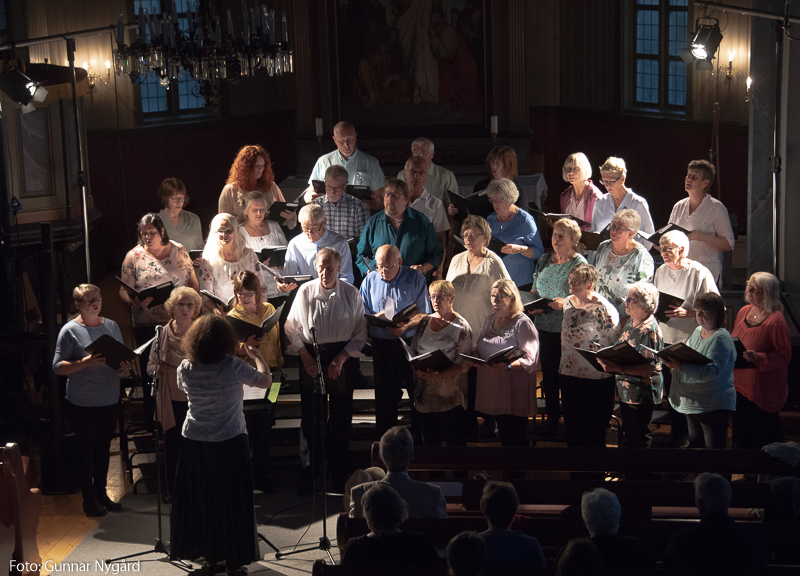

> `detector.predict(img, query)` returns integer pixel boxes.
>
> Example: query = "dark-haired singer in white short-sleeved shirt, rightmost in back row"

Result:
[669,160,736,284]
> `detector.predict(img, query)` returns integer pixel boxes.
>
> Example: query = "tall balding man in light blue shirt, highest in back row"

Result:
[304,122,386,206]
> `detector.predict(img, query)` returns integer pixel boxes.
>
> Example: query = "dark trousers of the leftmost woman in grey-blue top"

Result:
[64,400,119,501]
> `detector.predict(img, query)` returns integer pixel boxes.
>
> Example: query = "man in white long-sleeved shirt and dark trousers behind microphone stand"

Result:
[285,248,367,493]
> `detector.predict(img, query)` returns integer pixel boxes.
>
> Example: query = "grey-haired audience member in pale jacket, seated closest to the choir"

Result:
[348,426,447,518]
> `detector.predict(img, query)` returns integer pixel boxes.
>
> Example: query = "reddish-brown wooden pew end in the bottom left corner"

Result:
[0,443,42,575]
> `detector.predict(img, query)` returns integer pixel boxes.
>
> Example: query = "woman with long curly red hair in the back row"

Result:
[218,144,297,230]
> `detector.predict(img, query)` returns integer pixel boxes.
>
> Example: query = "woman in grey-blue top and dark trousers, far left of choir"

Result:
[53,284,131,517]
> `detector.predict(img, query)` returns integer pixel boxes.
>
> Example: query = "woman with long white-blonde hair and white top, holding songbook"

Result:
[200,214,266,314]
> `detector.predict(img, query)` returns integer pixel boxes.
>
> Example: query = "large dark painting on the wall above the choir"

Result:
[336,0,487,126]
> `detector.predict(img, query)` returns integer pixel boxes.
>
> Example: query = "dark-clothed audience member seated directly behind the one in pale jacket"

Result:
[342,482,439,566]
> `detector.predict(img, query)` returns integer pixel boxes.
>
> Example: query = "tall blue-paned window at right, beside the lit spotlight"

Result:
[624,0,692,117]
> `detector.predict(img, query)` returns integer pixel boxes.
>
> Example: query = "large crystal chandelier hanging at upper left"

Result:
[114,0,293,106]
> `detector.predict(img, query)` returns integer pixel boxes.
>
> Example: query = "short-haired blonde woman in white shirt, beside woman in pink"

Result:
[591,156,655,250]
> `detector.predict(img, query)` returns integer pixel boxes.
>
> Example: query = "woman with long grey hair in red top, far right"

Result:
[733,272,792,450]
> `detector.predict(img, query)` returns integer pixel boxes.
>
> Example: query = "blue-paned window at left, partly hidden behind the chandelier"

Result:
[131,0,214,121]
